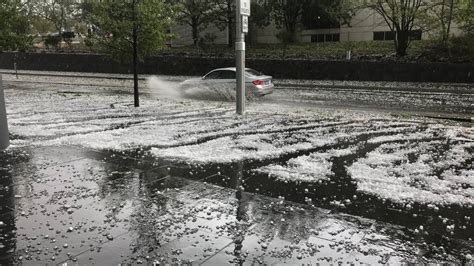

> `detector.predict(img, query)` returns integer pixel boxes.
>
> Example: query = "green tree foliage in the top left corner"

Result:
[0,0,33,51]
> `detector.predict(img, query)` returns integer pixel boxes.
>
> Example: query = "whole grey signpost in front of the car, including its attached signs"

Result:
[235,0,250,115]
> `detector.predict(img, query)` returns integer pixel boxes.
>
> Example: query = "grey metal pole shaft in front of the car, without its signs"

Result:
[235,0,245,115]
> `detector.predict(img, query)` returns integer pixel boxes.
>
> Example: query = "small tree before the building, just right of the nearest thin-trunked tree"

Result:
[178,0,212,46]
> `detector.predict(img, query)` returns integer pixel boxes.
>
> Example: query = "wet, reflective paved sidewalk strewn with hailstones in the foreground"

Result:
[0,146,472,265]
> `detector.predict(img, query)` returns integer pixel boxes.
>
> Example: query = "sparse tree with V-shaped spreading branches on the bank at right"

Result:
[365,0,425,56]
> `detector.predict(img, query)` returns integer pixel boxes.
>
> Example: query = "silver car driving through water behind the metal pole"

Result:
[183,67,274,96]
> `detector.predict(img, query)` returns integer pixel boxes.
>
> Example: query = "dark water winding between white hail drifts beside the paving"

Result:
[136,131,474,243]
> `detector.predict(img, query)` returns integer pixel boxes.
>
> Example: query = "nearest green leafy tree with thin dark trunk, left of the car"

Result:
[87,0,178,107]
